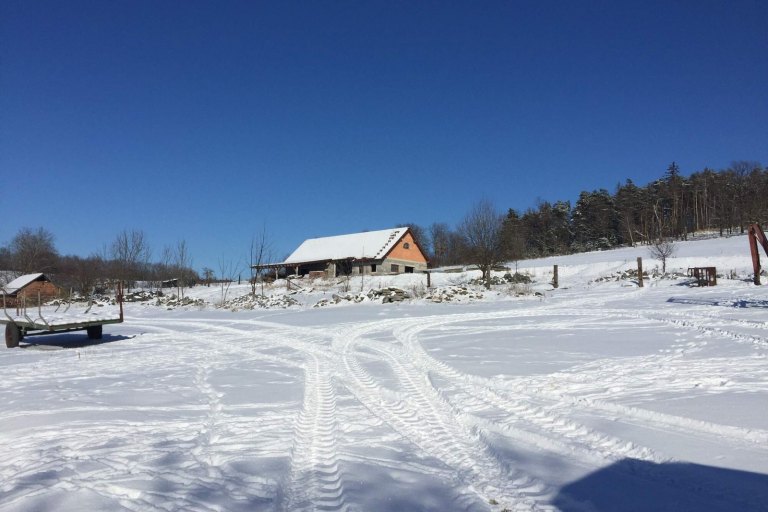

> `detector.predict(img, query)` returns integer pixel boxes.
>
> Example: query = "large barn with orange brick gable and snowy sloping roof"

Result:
[255,227,428,278]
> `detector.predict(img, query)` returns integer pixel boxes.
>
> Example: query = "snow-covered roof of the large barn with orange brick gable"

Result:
[284,227,408,264]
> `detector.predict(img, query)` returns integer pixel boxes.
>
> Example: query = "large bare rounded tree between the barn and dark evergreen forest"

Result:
[459,200,504,289]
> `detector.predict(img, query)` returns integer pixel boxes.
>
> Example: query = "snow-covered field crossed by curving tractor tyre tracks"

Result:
[0,237,768,512]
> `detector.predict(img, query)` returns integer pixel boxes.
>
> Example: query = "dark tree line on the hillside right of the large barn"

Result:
[403,161,768,282]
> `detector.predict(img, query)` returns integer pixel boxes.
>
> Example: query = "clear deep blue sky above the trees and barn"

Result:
[0,0,768,269]
